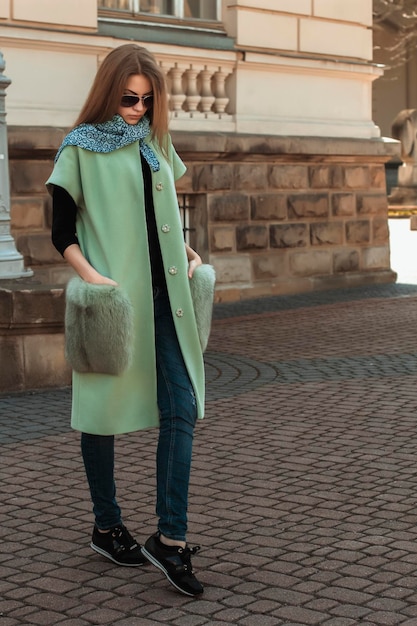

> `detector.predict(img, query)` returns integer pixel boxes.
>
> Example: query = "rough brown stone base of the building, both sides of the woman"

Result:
[0,127,398,392]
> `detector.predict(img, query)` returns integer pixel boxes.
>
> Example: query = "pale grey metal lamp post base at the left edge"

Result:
[0,52,33,280]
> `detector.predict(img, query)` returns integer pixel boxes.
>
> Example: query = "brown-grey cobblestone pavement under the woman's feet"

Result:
[0,285,417,626]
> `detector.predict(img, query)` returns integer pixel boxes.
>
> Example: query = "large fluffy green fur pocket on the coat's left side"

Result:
[65,276,133,375]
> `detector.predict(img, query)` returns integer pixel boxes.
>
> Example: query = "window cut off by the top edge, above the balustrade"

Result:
[98,0,221,20]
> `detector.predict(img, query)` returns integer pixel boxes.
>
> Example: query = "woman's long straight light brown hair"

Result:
[74,43,168,151]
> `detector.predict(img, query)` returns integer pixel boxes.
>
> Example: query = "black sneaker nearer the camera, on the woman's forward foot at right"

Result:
[142,533,204,596]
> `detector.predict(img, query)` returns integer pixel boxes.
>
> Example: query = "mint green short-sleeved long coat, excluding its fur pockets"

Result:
[47,138,205,435]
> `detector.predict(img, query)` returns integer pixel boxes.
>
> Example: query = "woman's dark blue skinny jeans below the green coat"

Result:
[81,288,197,541]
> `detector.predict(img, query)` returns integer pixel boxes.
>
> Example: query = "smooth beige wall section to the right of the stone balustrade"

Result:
[219,0,382,138]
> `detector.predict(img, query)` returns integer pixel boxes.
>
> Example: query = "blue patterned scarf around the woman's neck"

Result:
[55,114,160,172]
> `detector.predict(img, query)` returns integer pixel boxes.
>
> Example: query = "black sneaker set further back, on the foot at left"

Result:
[90,524,147,567]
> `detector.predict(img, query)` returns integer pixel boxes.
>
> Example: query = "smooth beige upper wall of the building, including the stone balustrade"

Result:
[0,0,382,138]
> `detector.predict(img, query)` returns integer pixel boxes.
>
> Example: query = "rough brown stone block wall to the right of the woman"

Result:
[174,134,398,300]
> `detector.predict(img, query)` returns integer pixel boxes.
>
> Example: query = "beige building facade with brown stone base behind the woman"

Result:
[0,0,398,384]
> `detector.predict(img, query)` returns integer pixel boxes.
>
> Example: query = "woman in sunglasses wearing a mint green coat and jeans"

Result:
[47,44,204,596]
